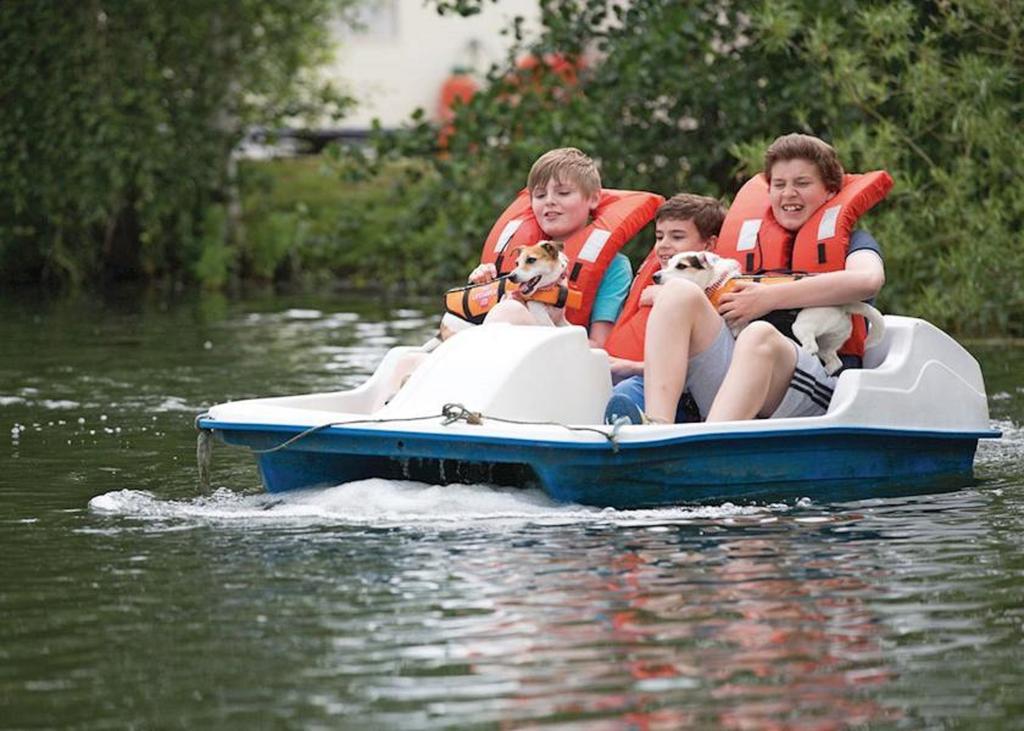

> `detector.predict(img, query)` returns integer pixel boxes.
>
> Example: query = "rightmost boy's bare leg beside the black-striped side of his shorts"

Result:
[708,321,797,422]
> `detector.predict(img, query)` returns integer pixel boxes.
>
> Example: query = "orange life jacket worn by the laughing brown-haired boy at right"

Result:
[715,170,893,356]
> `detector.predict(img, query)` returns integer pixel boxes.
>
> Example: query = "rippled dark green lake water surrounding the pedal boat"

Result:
[0,288,1024,729]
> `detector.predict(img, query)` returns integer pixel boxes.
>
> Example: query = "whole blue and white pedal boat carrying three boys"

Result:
[197,315,999,508]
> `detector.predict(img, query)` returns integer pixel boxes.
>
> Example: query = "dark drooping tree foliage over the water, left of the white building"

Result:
[0,0,352,285]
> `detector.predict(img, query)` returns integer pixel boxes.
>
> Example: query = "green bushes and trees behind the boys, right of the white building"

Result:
[340,0,1024,335]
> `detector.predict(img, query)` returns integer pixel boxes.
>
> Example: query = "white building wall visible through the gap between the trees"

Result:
[326,0,540,129]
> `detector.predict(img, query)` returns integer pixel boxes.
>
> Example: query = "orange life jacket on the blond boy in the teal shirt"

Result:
[480,188,665,327]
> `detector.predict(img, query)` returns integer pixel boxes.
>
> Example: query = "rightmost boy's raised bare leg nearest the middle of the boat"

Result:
[643,280,722,424]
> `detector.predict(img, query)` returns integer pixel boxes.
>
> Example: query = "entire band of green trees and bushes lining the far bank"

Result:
[0,0,1024,335]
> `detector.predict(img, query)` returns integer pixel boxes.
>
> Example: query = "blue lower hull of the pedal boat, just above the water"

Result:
[207,421,991,509]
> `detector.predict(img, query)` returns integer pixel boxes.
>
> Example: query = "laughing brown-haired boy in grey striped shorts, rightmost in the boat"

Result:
[609,134,885,423]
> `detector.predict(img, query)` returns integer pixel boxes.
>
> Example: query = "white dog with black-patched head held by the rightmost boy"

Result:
[654,251,886,375]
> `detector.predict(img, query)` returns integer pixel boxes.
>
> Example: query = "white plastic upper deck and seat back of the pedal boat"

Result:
[203,315,991,444]
